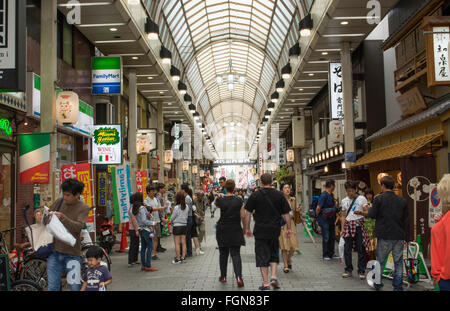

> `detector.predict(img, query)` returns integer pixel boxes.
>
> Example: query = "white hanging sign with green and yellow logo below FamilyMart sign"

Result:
[92,124,122,164]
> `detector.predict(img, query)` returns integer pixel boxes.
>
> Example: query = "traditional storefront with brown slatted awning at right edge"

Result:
[353,98,450,256]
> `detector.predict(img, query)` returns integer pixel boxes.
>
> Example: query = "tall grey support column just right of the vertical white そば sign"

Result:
[341,42,355,167]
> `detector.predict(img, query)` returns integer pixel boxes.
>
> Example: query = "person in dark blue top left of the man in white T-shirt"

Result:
[316,179,340,260]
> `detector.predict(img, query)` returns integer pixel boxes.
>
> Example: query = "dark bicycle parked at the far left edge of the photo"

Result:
[0,228,42,291]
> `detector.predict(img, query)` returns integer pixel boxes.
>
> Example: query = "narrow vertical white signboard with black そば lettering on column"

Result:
[328,62,344,120]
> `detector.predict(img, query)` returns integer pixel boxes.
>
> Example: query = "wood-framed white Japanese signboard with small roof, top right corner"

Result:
[422,16,450,87]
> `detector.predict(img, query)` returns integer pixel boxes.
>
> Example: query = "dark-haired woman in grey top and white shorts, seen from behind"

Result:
[171,192,189,264]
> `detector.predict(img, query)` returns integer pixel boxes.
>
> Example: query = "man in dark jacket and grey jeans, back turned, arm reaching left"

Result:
[355,176,409,291]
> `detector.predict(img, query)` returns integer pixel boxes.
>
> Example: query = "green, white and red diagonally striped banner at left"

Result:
[19,133,50,183]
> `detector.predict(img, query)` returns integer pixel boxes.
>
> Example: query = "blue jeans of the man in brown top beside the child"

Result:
[47,250,82,291]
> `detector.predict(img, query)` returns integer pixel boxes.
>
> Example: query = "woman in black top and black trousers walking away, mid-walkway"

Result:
[216,179,245,287]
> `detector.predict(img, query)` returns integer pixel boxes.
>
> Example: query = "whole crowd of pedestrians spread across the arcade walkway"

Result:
[36,174,450,291]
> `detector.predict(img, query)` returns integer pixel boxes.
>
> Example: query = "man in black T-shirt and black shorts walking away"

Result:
[244,174,291,290]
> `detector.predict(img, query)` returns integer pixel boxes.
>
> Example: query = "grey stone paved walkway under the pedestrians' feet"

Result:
[108,210,430,291]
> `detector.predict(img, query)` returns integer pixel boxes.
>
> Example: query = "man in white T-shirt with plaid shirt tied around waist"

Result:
[341,181,370,280]
